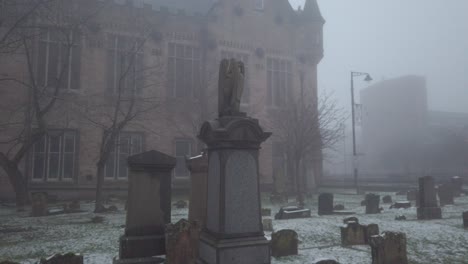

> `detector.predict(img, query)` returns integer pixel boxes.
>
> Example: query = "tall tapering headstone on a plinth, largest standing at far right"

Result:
[417,176,442,220]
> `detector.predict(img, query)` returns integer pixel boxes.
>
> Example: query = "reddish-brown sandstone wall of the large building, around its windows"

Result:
[0,0,323,198]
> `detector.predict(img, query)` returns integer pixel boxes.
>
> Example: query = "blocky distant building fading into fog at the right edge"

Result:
[359,76,468,179]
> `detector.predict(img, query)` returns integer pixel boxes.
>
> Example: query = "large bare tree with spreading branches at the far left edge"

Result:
[0,0,106,210]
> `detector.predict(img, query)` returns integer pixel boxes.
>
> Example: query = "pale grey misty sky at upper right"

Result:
[290,0,468,112]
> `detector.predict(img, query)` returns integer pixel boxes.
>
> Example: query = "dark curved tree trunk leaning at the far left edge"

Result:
[0,153,28,211]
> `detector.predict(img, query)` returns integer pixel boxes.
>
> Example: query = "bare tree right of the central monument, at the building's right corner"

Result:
[273,88,346,206]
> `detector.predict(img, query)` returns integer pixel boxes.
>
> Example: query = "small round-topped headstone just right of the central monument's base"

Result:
[271,229,299,257]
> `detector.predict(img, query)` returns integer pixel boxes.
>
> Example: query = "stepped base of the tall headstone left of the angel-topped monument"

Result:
[119,235,166,258]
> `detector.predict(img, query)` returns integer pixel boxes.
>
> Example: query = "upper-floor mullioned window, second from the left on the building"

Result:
[107,34,144,94]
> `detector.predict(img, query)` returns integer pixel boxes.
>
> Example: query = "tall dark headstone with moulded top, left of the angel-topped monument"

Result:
[114,150,176,263]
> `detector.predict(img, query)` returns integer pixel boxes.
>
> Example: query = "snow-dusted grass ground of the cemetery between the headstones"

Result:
[0,190,468,264]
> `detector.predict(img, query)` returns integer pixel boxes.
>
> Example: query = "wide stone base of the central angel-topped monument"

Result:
[196,233,270,264]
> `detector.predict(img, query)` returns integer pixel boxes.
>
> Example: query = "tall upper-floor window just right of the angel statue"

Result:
[267,58,292,107]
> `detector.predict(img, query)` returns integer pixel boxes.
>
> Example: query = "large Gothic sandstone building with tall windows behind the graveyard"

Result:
[0,0,324,198]
